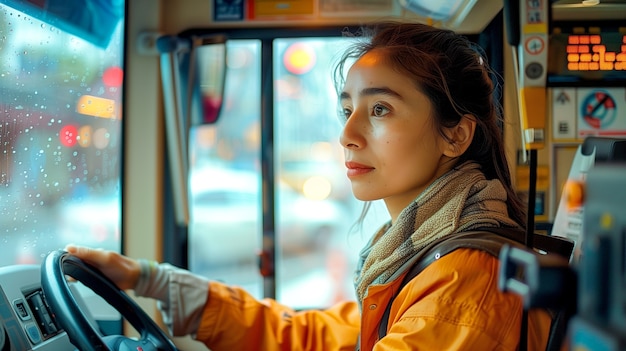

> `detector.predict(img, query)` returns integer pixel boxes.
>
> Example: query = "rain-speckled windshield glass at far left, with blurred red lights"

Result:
[0,1,124,266]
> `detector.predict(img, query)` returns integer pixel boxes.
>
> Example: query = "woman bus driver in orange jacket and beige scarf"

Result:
[66,23,549,351]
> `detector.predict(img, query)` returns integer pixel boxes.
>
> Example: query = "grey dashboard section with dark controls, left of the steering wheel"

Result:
[0,265,77,351]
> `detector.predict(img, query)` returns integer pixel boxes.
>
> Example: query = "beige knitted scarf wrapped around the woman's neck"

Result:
[355,162,518,303]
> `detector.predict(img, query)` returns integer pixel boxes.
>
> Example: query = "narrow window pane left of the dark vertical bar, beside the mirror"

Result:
[189,40,263,296]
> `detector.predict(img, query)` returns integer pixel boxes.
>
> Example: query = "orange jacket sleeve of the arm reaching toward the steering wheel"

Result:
[196,282,360,351]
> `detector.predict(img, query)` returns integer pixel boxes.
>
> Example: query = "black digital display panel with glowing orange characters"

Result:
[548,27,626,85]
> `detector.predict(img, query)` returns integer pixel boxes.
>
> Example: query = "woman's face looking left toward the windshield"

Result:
[340,51,452,220]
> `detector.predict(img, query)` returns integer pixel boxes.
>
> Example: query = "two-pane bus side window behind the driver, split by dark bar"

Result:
[189,38,385,308]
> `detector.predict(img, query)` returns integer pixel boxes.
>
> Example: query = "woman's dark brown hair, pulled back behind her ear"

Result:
[334,22,526,227]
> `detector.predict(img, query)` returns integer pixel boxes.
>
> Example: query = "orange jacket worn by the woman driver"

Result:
[196,249,550,351]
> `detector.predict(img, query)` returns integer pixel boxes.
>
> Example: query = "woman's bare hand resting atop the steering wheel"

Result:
[65,244,141,290]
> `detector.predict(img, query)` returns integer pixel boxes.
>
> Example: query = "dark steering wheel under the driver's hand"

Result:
[41,250,177,351]
